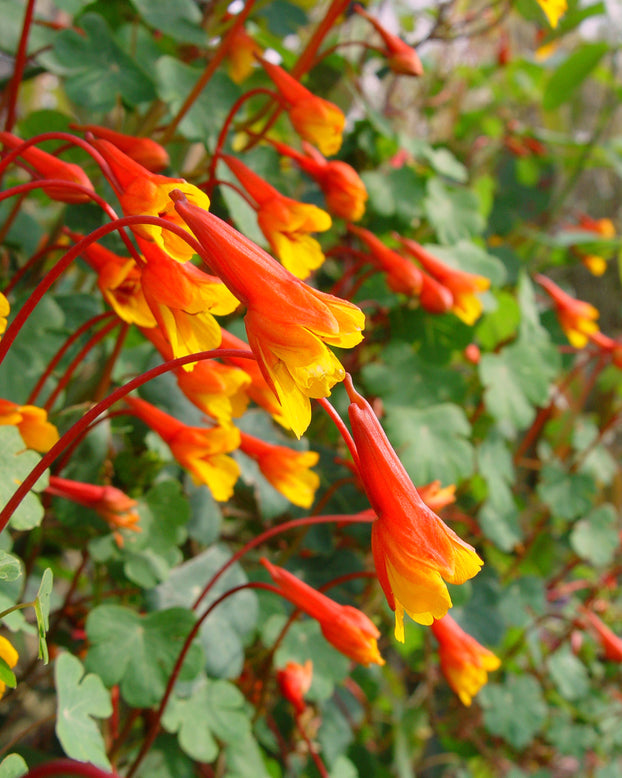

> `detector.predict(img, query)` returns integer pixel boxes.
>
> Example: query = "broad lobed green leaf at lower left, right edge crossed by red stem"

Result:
[86,605,202,708]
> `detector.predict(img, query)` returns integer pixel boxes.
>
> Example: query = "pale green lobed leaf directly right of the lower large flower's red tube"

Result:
[385,403,474,486]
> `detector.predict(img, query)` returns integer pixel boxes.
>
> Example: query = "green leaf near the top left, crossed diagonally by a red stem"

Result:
[155,57,240,146]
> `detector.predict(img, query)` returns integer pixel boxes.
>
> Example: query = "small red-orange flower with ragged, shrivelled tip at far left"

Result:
[45,475,141,546]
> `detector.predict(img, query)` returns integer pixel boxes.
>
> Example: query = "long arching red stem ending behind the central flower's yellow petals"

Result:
[0,346,255,532]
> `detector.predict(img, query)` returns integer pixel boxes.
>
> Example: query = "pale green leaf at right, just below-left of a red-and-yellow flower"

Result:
[479,338,559,437]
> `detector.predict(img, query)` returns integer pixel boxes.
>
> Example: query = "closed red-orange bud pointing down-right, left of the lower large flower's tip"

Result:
[261,557,384,665]
